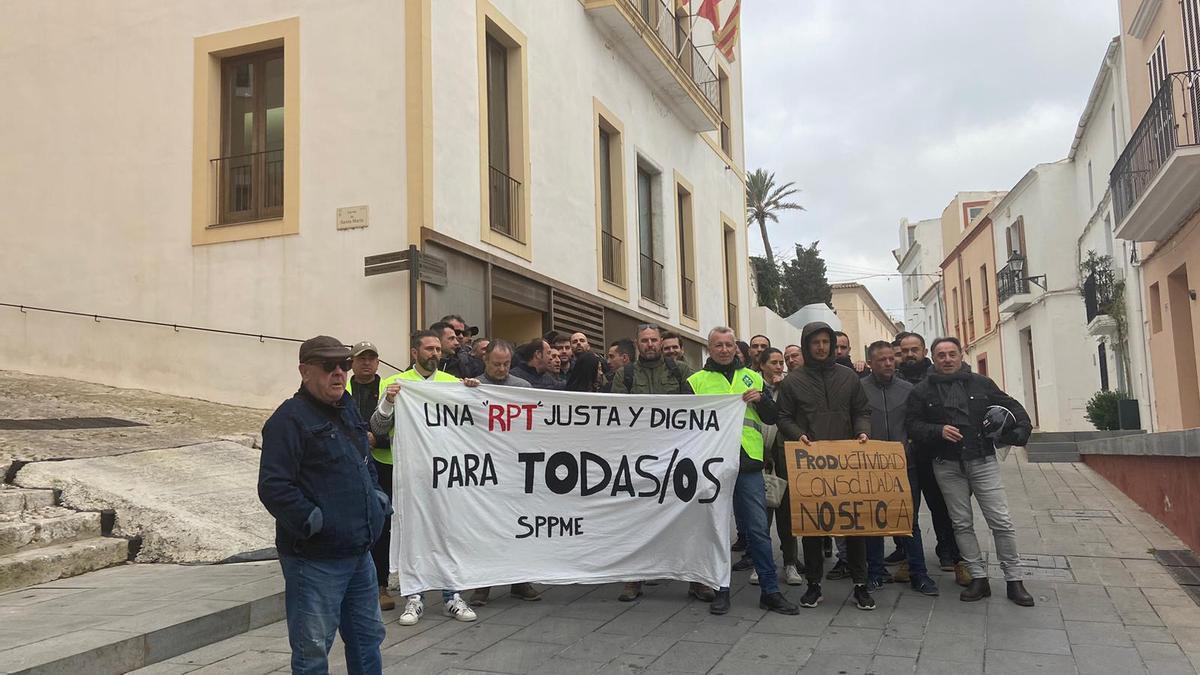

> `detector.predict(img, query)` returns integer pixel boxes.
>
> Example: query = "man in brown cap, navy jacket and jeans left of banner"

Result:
[258,335,391,673]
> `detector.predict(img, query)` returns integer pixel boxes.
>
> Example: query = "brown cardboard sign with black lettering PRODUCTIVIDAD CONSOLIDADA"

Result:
[784,441,912,537]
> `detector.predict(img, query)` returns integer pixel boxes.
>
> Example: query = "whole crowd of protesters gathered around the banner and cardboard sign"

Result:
[259,315,1033,671]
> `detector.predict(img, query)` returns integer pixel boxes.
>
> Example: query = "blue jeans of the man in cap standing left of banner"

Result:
[280,552,384,675]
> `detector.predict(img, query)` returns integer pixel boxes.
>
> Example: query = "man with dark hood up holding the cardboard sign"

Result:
[776,321,875,609]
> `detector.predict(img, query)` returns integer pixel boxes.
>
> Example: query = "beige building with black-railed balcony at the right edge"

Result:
[1110,0,1200,431]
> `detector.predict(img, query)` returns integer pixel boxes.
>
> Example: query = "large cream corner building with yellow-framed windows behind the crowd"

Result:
[0,0,750,407]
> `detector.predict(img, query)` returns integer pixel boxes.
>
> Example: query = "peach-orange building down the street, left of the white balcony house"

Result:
[941,192,1004,388]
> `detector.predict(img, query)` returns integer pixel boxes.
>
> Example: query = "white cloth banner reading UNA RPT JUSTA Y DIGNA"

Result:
[392,382,745,595]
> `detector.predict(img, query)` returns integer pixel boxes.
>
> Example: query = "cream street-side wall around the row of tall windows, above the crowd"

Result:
[433,0,751,334]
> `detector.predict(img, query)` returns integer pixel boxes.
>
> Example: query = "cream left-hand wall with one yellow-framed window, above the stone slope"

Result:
[0,0,412,407]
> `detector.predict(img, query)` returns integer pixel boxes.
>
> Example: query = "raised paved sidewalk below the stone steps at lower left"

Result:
[0,561,283,674]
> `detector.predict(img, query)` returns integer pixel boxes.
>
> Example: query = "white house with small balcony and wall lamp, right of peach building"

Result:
[991,40,1152,431]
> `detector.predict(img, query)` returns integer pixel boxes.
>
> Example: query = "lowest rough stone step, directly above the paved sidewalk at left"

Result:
[0,537,130,591]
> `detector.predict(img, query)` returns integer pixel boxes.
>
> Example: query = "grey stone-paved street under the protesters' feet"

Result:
[139,458,1200,675]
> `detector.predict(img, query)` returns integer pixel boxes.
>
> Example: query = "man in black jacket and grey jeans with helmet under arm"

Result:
[906,338,1033,607]
